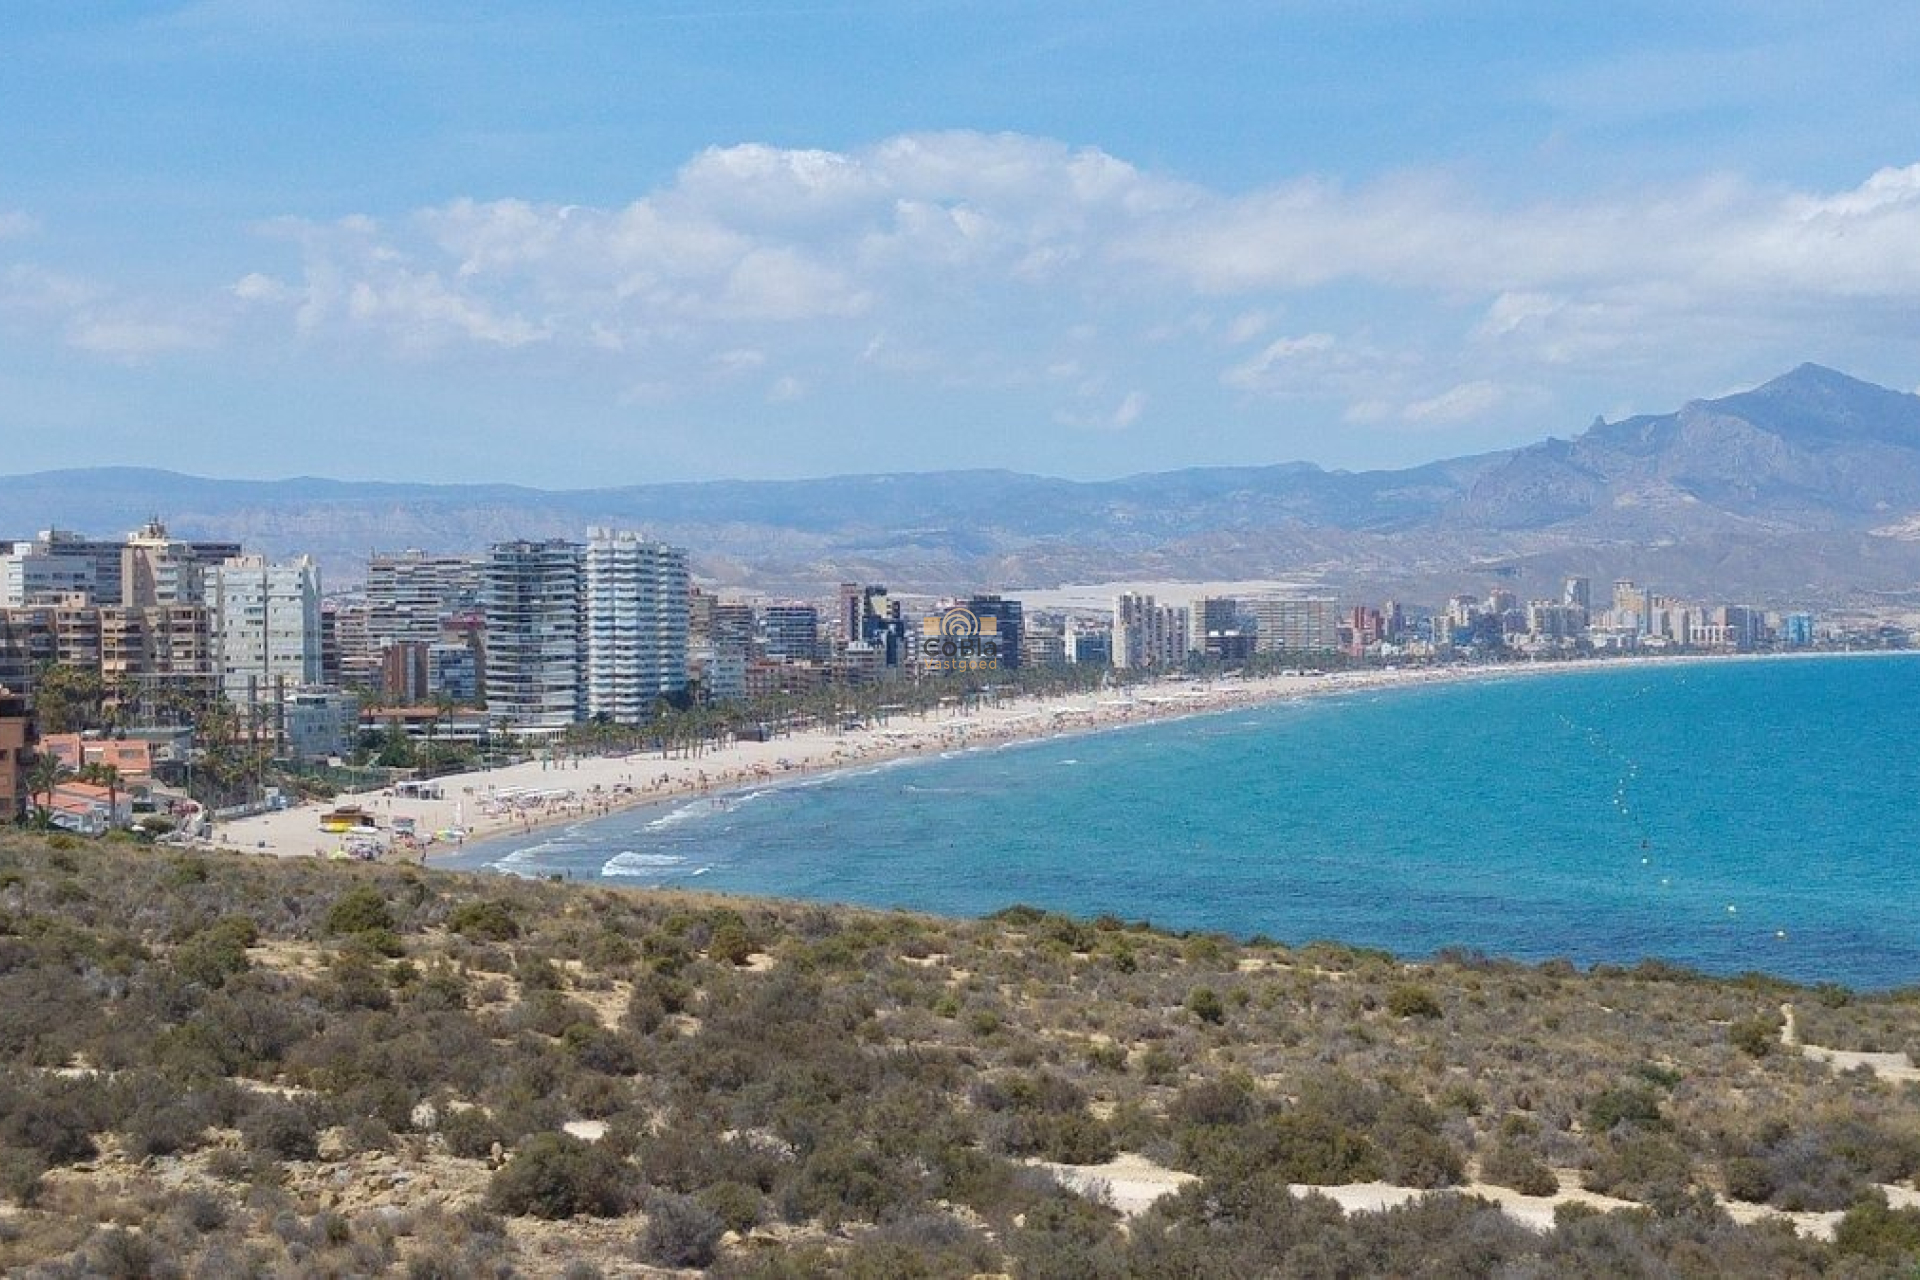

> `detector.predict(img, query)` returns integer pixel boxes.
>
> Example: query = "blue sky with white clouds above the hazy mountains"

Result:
[0,0,1920,487]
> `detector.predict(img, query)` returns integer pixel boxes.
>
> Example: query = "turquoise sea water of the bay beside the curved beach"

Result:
[441,656,1920,988]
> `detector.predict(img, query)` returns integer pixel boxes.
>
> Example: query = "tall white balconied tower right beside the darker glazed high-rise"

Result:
[586,530,693,723]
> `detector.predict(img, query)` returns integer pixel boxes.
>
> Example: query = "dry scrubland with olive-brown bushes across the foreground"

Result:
[0,837,1920,1278]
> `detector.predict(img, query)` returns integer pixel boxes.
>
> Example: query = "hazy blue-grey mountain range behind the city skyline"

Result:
[11,365,1920,604]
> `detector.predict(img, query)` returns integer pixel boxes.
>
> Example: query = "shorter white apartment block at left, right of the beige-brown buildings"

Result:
[204,557,321,708]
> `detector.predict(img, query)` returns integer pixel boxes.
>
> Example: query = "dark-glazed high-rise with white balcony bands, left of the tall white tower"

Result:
[480,539,586,733]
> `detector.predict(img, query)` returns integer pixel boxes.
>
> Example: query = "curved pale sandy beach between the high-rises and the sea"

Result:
[215,651,1907,865]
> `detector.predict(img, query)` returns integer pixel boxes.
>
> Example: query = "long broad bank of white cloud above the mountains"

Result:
[217,132,1920,422]
